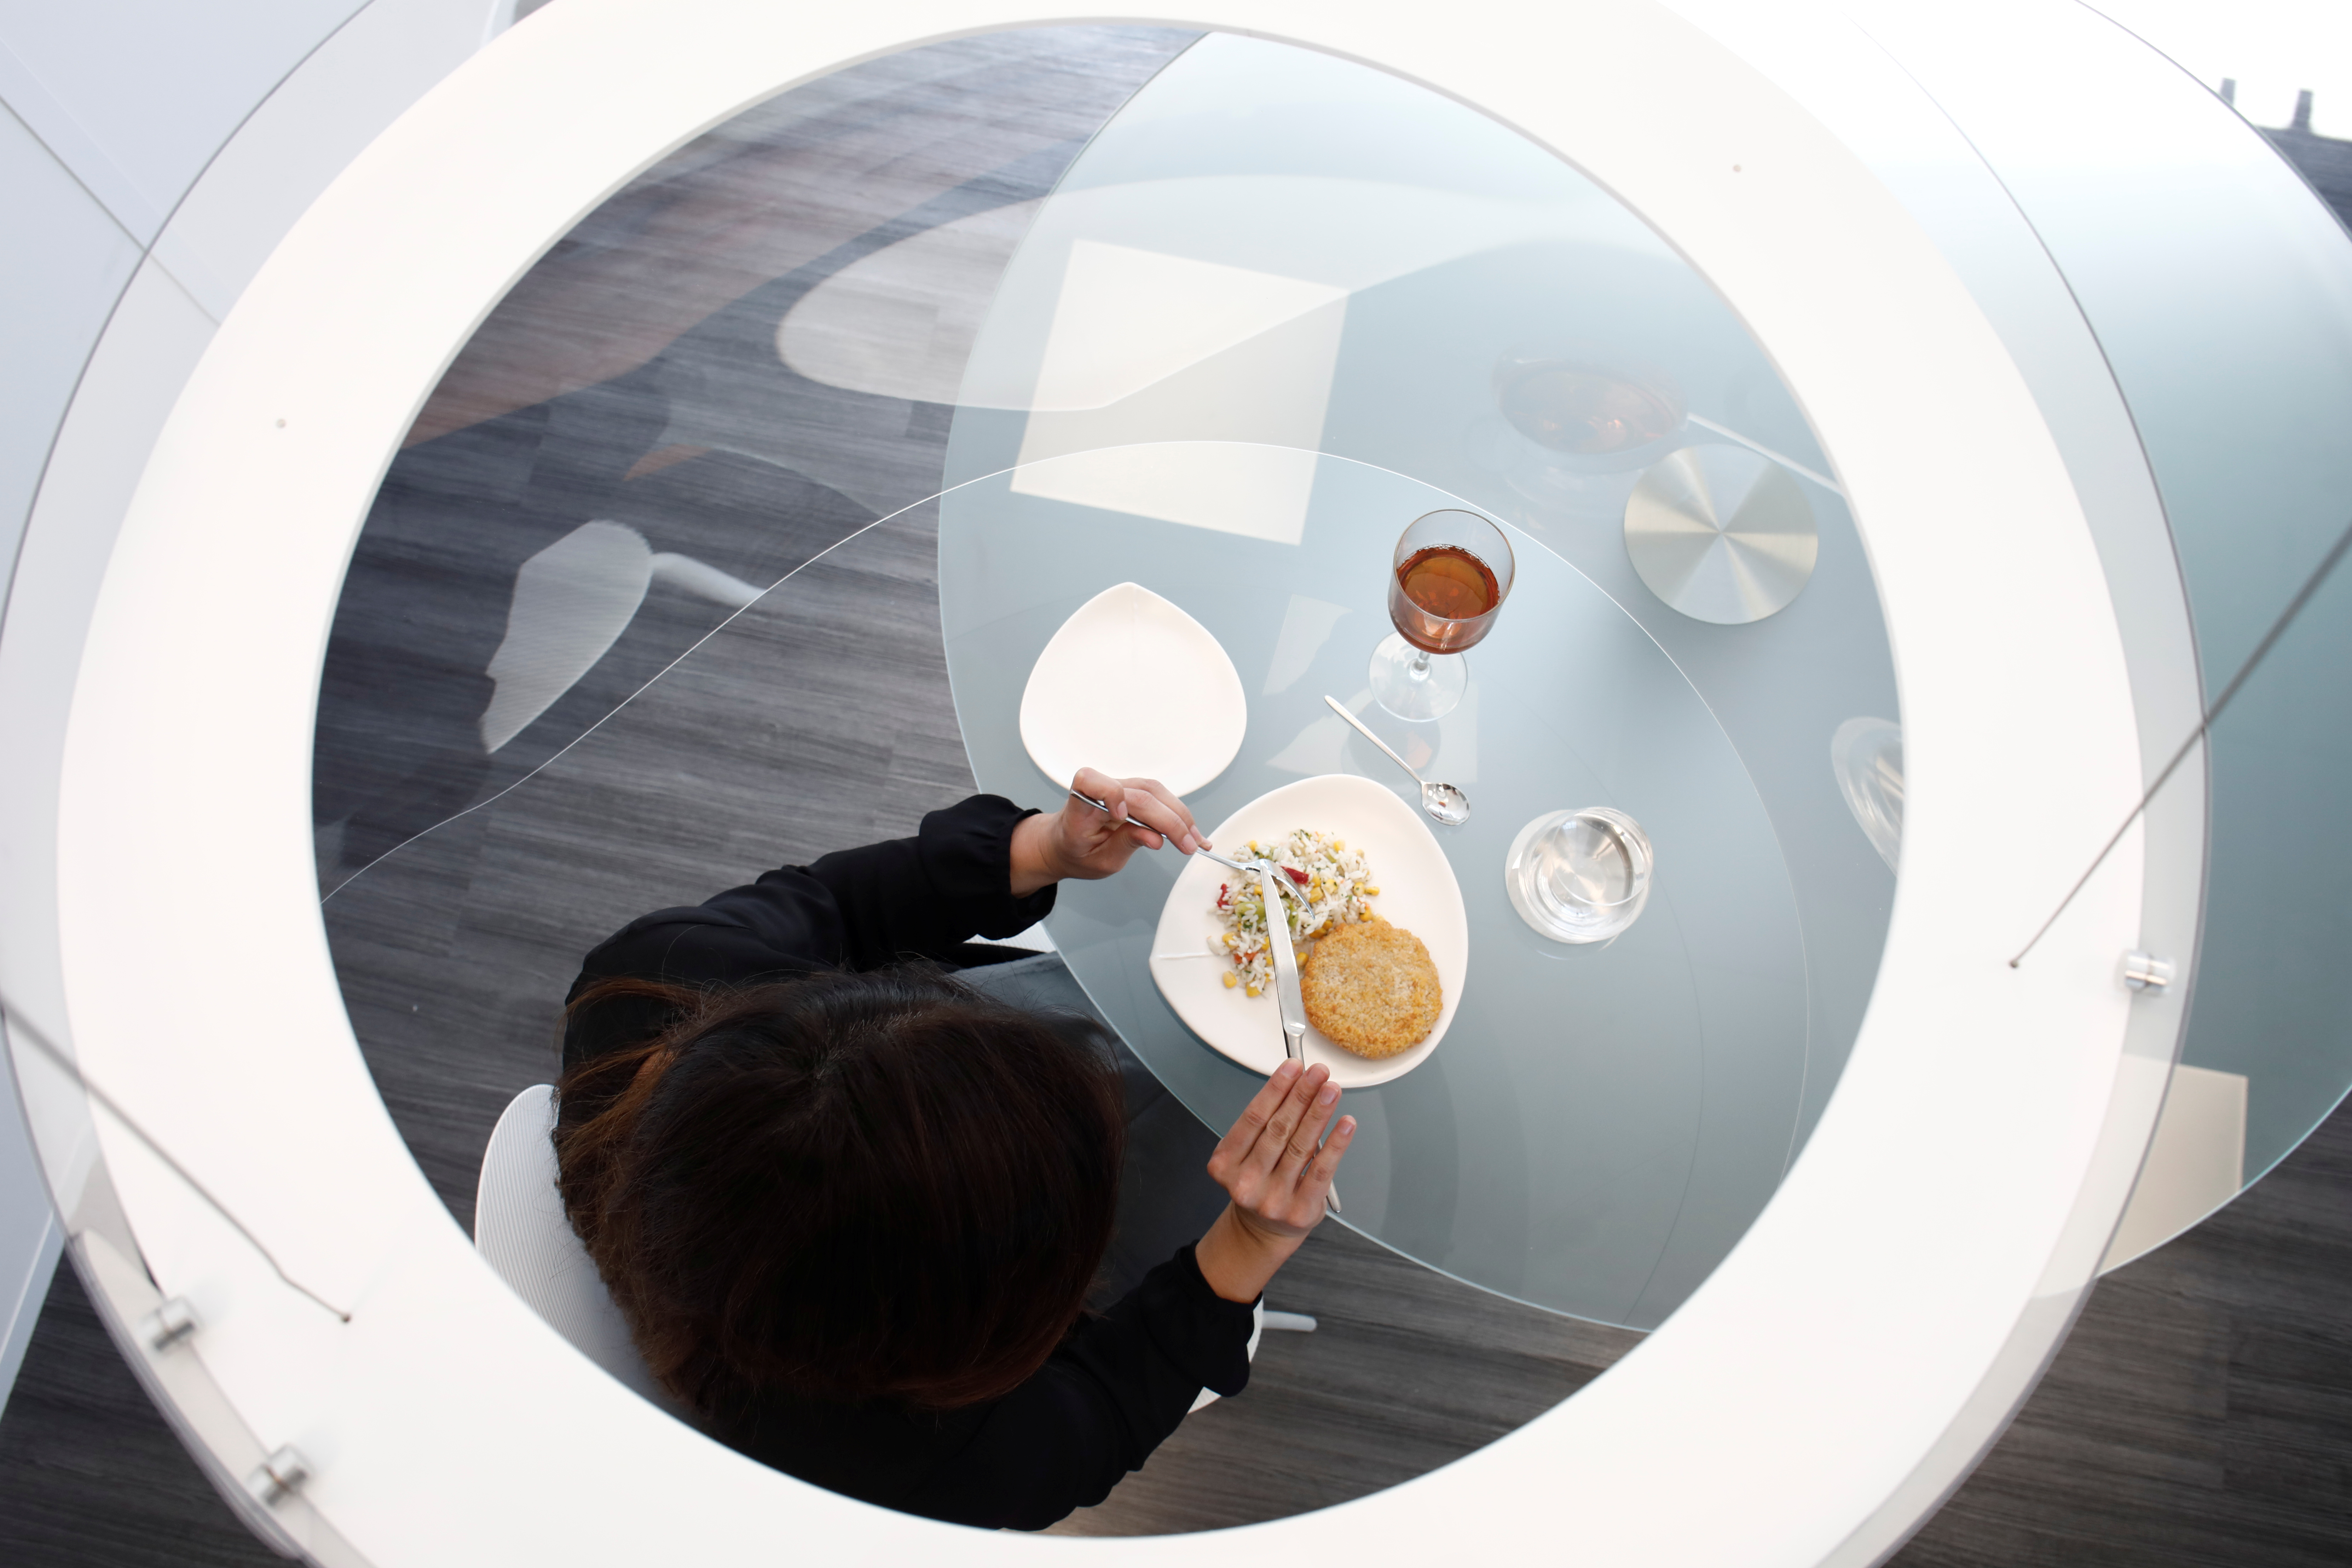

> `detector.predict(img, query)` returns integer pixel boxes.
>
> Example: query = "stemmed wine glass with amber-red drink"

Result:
[1371,508,1512,724]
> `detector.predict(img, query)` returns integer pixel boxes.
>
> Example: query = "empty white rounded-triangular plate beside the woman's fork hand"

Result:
[1021,583,1249,794]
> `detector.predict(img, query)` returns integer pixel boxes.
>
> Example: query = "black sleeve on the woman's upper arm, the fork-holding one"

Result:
[565,794,1054,1067]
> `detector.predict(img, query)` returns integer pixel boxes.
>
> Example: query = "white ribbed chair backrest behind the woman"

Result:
[473,1084,687,1420]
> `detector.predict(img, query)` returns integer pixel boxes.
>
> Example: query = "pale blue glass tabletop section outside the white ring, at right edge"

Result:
[1863,7,2352,1213]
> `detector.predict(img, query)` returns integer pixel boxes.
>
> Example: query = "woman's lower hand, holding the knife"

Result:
[1192,1063,1355,1302]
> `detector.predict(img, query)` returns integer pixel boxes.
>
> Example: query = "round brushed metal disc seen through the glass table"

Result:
[1625,447,1820,625]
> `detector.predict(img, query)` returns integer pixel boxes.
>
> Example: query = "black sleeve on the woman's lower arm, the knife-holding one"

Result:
[903,1246,1254,1531]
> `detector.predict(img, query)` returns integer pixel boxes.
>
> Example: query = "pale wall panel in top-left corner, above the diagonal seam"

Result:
[0,0,369,244]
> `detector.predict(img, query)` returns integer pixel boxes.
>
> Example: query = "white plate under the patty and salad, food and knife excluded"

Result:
[1152,774,1470,1088]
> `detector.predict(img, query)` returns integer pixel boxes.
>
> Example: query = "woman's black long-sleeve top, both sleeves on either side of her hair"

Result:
[565,794,1251,1531]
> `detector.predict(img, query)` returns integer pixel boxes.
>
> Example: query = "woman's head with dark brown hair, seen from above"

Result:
[555,971,1122,1413]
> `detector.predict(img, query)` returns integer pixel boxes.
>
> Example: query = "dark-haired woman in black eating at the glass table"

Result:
[555,771,1355,1531]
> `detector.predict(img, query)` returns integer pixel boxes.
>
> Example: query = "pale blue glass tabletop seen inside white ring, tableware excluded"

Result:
[938,35,1900,1326]
